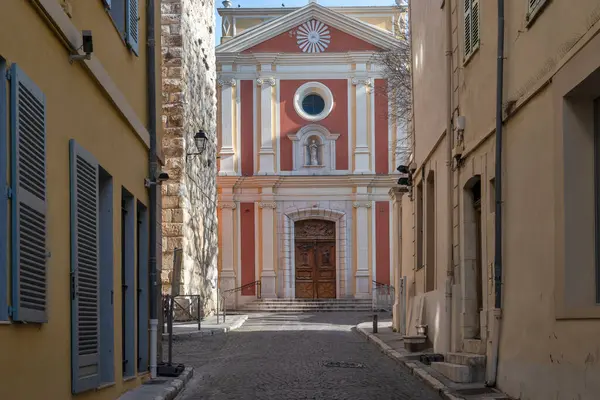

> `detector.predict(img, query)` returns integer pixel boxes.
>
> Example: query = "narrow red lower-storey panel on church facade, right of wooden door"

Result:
[375,201,390,285]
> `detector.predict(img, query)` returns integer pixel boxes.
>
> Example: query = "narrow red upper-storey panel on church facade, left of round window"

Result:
[240,80,254,176]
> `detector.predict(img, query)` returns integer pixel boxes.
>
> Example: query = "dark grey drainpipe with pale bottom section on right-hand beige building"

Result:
[486,0,504,386]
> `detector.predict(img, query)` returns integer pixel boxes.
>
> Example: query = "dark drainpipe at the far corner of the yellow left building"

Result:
[146,0,159,379]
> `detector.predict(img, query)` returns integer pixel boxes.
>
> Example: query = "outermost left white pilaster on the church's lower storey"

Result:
[219,201,237,307]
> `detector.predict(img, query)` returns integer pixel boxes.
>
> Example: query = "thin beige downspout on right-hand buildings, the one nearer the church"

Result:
[444,0,454,351]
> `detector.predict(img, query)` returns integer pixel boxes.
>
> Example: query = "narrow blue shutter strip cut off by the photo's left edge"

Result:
[0,57,8,321]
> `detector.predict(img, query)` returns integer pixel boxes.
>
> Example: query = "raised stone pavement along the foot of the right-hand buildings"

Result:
[356,317,509,400]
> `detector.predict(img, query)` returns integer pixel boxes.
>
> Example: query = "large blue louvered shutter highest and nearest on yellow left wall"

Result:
[10,64,48,323]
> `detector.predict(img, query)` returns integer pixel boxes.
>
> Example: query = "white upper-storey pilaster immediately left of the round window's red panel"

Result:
[256,74,276,175]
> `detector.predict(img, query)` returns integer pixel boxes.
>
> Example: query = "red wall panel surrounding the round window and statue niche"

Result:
[279,79,348,171]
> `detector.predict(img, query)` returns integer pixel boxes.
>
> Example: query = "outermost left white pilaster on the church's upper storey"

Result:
[217,78,237,176]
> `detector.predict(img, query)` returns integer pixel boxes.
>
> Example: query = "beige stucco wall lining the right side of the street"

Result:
[403,0,600,400]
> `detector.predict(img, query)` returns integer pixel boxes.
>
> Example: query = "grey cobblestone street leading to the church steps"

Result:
[173,313,440,400]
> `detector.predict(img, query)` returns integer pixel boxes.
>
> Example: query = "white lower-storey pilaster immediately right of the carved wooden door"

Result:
[353,197,372,298]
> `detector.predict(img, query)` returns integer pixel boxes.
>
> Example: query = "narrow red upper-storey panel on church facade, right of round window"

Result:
[375,79,389,174]
